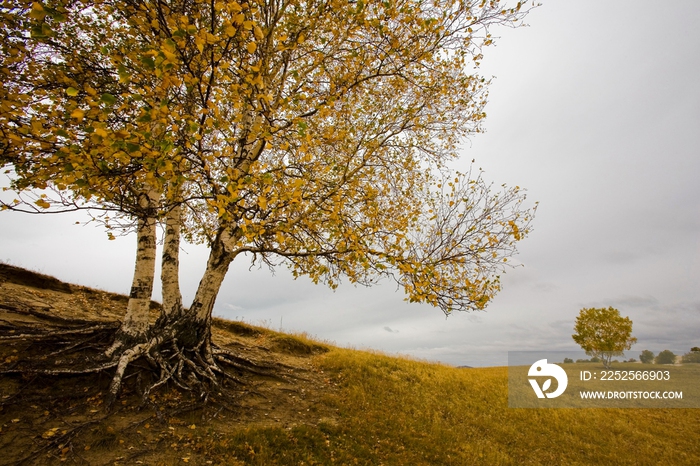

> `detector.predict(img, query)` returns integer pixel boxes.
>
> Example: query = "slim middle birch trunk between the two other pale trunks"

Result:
[160,205,182,315]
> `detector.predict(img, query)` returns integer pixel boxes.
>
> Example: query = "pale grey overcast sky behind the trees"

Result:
[0,0,700,366]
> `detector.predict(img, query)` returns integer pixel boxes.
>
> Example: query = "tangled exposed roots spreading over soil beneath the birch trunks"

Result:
[0,312,290,409]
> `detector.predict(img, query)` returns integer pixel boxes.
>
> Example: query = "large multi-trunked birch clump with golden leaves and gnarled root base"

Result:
[0,0,534,404]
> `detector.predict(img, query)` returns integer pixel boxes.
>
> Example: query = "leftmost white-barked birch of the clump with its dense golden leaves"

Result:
[0,1,187,350]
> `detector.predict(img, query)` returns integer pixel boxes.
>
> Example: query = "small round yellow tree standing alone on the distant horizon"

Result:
[572,307,637,369]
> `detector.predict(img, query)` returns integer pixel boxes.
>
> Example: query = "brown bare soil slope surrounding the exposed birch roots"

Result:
[0,264,336,466]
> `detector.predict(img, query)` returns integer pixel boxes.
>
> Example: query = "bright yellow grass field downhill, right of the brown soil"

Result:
[226,349,700,465]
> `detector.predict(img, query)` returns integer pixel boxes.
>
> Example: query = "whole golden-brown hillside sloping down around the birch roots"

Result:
[0,268,700,465]
